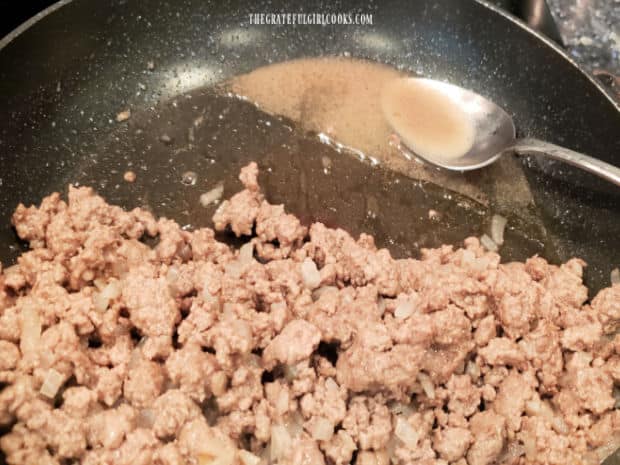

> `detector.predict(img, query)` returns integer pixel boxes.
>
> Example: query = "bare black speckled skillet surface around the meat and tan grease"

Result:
[0,0,620,289]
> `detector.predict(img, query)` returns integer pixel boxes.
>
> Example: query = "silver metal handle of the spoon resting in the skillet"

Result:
[513,139,620,186]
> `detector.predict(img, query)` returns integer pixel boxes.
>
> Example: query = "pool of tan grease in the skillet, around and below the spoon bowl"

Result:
[229,57,535,212]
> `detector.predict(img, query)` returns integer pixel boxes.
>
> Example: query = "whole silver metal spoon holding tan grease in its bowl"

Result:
[381,78,620,186]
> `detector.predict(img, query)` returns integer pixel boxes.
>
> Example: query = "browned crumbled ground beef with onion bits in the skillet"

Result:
[0,160,620,465]
